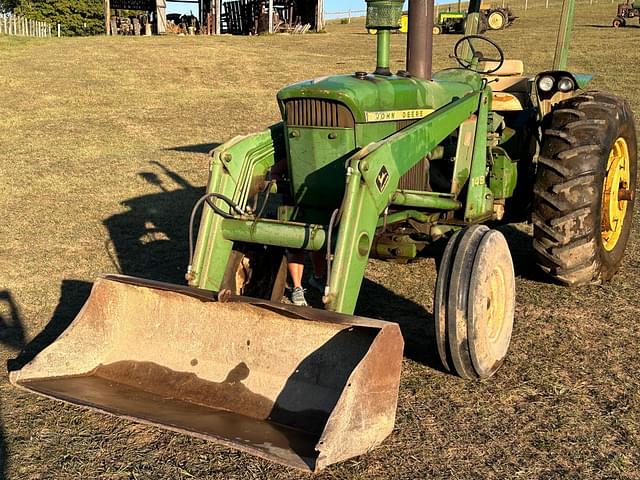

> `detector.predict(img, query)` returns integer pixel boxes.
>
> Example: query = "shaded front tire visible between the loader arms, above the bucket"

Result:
[221,244,287,302]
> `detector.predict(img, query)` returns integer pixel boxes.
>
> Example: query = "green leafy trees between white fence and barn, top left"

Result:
[13,0,104,35]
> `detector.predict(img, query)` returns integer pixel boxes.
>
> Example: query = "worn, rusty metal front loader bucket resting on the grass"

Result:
[10,277,403,471]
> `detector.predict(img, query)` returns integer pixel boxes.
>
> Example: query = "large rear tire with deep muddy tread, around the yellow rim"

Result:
[532,92,637,285]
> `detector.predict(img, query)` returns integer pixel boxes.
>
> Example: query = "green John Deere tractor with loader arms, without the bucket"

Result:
[188,0,637,370]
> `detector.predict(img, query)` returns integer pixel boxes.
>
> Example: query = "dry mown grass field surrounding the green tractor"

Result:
[0,4,640,480]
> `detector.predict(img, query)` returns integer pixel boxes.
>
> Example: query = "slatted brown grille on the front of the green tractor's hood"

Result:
[285,98,355,128]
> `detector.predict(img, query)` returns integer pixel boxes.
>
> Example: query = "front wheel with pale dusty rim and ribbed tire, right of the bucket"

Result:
[434,225,515,379]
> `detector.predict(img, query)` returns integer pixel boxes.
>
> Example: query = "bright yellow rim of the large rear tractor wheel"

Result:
[601,137,631,252]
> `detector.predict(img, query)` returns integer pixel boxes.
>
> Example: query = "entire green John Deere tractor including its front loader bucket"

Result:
[10,0,637,471]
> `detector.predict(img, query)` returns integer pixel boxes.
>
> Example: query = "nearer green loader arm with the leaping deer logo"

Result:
[325,91,488,314]
